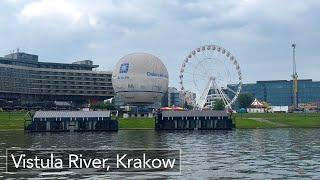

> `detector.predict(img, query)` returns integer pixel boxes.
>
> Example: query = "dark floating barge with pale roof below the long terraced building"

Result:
[25,111,118,132]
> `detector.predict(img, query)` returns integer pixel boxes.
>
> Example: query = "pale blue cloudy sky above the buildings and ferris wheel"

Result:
[0,0,320,86]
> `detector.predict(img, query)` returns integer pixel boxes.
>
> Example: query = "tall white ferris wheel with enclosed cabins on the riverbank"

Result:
[179,45,242,109]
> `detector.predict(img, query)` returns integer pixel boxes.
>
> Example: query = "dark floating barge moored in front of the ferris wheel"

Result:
[155,110,235,130]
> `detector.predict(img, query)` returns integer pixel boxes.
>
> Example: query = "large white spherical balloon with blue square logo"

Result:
[112,53,168,104]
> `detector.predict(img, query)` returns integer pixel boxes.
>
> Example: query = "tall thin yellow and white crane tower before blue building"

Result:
[292,43,298,110]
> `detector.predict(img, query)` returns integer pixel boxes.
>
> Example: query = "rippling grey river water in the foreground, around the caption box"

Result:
[0,129,320,179]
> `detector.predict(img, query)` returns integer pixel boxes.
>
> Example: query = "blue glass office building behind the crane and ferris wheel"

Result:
[228,79,320,106]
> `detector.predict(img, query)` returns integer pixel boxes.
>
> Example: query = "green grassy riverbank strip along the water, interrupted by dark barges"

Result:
[0,111,320,131]
